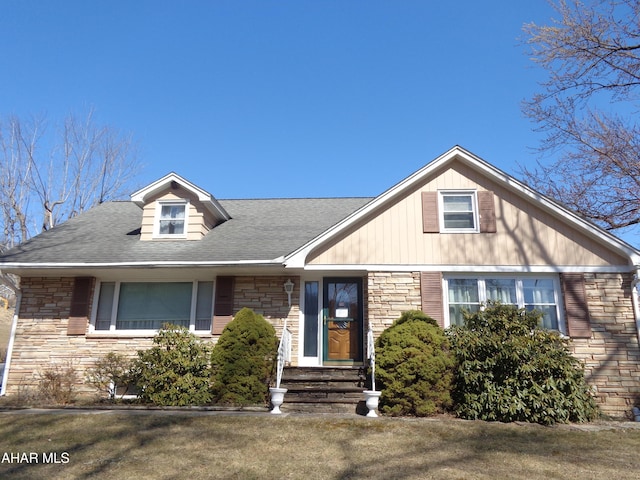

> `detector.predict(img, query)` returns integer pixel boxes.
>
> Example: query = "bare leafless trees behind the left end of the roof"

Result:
[0,111,139,249]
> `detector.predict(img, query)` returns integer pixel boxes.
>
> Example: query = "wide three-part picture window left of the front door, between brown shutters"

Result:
[95,282,213,331]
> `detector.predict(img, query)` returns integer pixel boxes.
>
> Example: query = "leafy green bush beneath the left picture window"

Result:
[131,325,211,406]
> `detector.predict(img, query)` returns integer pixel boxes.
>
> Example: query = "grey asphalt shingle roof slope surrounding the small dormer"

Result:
[0,198,372,268]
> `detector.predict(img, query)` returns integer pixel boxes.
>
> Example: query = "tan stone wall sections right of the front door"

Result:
[366,272,640,417]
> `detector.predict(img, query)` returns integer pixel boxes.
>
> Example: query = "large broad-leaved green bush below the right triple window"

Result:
[449,304,597,425]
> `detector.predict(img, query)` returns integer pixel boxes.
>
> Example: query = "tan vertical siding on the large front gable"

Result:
[308,162,628,266]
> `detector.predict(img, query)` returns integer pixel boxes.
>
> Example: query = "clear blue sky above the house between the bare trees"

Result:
[0,0,553,199]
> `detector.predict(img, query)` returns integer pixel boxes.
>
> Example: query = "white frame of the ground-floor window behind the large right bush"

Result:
[442,274,567,335]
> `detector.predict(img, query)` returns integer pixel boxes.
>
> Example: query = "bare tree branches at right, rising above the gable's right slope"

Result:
[523,0,640,236]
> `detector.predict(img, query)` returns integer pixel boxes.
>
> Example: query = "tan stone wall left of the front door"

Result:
[7,277,300,395]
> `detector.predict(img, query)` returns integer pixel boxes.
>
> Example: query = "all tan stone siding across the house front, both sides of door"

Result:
[7,272,640,417]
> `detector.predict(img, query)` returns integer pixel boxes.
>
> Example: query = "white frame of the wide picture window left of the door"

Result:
[89,280,215,337]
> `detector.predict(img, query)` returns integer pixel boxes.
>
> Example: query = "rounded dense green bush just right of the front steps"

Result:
[376,310,454,417]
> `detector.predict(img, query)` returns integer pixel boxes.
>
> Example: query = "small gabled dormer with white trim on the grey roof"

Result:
[131,172,231,241]
